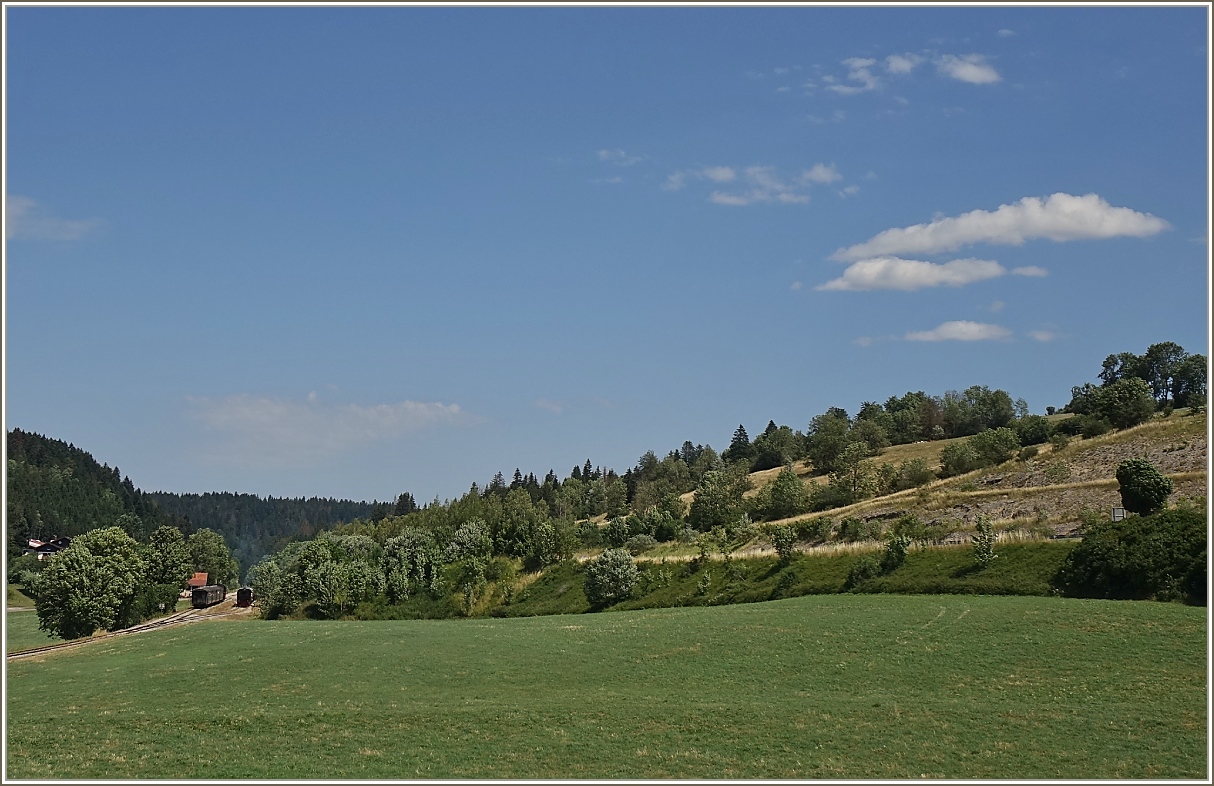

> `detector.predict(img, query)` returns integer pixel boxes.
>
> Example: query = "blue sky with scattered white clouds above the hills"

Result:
[5,6,1209,501]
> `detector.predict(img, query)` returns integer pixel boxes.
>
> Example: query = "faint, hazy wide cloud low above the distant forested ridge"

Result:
[187,392,465,468]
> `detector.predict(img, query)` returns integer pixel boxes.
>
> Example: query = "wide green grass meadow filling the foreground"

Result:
[7,595,1208,779]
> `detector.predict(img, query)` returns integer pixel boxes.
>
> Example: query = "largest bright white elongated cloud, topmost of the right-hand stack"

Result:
[833,193,1169,261]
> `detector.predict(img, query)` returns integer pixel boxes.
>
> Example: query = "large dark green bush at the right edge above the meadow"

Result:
[1054,508,1207,604]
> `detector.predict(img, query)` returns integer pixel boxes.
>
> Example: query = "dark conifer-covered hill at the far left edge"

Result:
[7,429,185,554]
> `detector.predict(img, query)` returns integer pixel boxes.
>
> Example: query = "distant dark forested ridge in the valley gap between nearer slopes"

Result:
[148,491,375,570]
